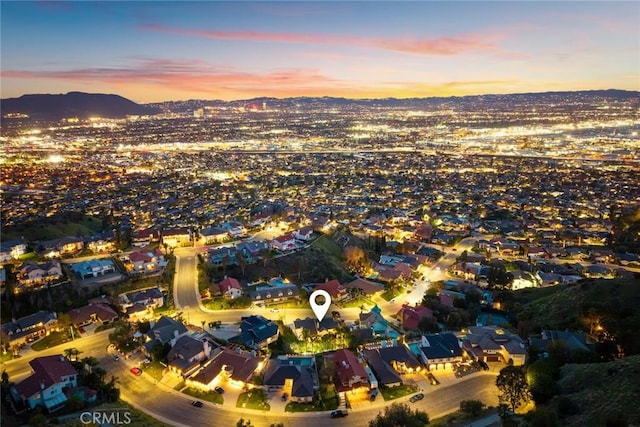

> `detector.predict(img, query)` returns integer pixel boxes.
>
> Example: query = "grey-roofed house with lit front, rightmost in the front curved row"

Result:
[462,325,527,366]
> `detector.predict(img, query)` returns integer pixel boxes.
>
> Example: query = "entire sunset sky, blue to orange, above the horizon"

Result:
[1,2,640,102]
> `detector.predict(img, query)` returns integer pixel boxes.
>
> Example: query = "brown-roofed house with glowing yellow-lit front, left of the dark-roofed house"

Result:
[186,348,264,391]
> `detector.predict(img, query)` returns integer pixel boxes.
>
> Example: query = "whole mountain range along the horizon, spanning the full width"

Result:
[0,89,640,120]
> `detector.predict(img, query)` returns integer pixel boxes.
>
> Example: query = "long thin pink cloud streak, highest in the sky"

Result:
[139,24,522,58]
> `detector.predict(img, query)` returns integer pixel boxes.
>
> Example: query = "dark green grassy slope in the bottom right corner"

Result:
[556,356,640,426]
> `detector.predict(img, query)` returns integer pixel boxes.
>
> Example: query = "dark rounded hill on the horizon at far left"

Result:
[0,92,160,120]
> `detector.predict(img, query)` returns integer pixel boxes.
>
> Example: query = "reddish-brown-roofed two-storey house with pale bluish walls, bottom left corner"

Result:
[12,354,78,413]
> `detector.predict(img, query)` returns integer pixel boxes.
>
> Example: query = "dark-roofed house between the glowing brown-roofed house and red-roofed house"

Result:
[262,356,320,402]
